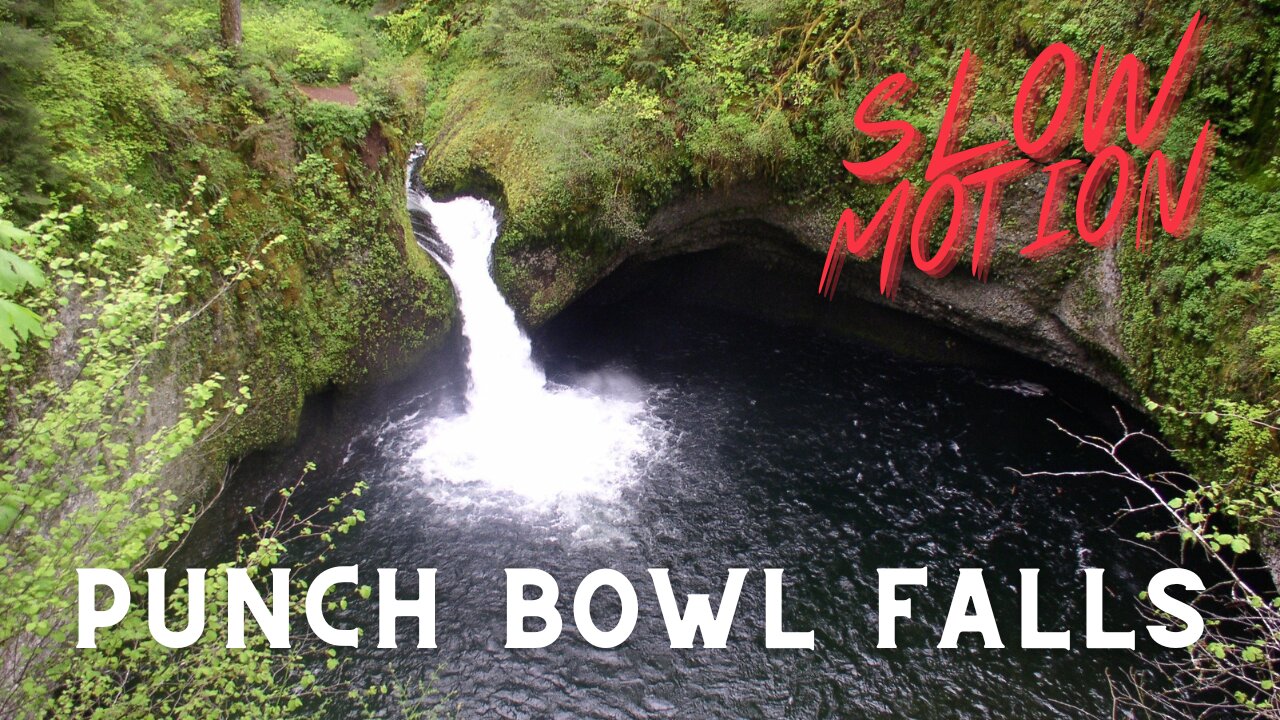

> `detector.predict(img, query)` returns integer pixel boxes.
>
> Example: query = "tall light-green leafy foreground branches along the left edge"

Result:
[0,180,280,716]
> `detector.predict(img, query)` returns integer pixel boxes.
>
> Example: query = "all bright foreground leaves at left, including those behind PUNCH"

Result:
[0,187,348,717]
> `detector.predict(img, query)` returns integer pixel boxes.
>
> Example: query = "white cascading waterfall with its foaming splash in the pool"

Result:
[408,158,660,503]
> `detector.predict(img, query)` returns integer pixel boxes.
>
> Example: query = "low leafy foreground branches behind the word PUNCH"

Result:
[57,466,373,720]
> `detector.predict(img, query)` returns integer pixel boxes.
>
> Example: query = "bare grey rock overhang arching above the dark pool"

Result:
[504,176,1135,401]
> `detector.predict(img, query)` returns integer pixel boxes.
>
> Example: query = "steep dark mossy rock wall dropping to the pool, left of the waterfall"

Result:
[165,137,454,500]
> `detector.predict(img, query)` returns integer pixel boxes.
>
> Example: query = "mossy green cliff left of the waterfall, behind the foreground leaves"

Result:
[0,0,454,481]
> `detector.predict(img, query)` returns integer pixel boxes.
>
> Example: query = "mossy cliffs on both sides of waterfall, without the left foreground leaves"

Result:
[0,0,1280,504]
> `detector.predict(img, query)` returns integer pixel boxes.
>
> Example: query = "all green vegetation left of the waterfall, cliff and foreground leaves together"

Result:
[0,0,453,717]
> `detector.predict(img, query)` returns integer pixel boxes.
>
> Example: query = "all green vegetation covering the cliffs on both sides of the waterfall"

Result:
[0,0,1280,715]
